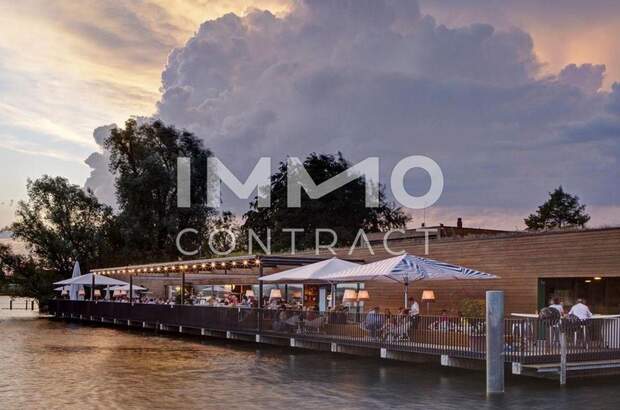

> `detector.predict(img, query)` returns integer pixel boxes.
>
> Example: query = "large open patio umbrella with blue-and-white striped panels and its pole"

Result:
[320,253,498,305]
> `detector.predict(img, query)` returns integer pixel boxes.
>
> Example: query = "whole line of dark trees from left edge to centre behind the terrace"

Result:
[0,119,407,300]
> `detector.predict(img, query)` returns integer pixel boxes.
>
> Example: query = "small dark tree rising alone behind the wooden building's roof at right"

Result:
[524,186,590,230]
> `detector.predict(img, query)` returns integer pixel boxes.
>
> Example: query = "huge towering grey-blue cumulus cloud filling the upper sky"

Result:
[85,0,618,227]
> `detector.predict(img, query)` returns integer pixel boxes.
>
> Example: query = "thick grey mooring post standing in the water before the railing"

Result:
[486,290,504,394]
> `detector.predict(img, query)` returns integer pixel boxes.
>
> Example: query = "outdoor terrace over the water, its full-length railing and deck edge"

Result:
[50,300,620,376]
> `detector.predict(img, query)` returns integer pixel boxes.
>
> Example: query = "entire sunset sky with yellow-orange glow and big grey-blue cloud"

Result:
[0,0,620,229]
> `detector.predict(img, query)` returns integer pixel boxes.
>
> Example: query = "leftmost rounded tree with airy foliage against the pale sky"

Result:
[9,175,113,277]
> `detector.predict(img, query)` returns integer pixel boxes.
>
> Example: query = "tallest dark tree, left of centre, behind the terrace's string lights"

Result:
[105,119,213,262]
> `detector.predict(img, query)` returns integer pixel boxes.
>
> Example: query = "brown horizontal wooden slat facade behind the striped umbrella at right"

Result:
[324,228,620,313]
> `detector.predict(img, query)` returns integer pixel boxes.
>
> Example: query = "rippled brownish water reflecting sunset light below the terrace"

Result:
[0,299,620,410]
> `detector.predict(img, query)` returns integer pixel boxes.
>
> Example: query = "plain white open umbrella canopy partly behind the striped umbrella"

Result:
[258,257,360,283]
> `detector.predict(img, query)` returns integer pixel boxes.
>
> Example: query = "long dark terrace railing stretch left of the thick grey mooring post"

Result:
[50,300,485,359]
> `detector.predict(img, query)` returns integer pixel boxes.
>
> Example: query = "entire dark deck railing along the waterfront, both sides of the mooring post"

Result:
[51,300,620,364]
